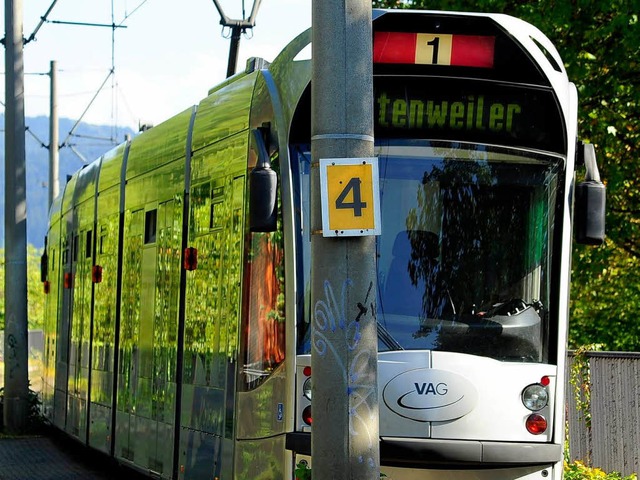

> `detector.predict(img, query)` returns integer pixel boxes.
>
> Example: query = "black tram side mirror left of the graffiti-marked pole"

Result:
[249,128,278,232]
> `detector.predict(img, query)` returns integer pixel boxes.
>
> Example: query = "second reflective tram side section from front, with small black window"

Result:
[115,200,182,475]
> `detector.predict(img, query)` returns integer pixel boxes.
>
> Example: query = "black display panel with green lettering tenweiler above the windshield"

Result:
[374,76,566,153]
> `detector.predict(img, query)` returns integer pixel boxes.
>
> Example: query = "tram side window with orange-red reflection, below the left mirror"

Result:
[242,231,285,390]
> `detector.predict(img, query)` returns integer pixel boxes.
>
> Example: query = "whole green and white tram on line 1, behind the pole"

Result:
[42,10,604,480]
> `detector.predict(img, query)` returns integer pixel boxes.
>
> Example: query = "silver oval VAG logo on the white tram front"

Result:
[382,368,478,422]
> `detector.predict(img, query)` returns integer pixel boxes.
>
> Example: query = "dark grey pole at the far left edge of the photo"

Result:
[4,0,29,433]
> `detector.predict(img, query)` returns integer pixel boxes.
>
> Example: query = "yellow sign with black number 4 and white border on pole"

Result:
[320,157,380,237]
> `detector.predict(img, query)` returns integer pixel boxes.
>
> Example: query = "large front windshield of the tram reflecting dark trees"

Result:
[296,141,564,362]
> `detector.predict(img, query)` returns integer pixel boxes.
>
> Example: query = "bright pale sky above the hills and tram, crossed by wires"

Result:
[0,0,311,130]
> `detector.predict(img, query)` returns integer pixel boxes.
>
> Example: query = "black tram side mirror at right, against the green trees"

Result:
[573,143,607,245]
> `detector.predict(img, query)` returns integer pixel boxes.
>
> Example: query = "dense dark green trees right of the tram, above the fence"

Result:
[373,0,640,350]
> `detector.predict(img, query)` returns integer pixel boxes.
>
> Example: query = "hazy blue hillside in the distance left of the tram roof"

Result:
[0,114,133,248]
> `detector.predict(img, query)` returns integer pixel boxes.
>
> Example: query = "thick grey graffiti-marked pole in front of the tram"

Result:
[311,0,380,480]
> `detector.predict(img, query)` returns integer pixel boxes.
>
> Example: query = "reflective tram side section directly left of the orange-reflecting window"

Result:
[179,144,246,480]
